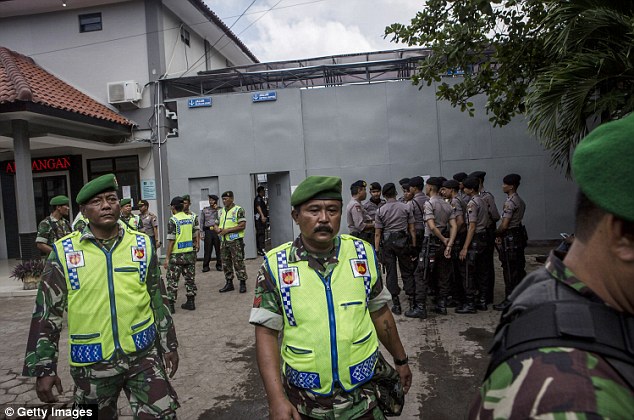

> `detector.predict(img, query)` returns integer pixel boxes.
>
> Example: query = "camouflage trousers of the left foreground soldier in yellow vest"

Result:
[70,348,180,419]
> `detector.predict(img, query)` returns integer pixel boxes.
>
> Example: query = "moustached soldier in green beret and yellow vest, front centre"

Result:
[249,176,411,419]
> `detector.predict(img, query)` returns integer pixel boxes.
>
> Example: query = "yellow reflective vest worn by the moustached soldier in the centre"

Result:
[266,235,379,395]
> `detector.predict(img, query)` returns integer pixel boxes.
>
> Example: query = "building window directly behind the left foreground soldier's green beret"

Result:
[88,156,141,209]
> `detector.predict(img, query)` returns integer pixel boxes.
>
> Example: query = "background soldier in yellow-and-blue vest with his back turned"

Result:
[163,197,198,313]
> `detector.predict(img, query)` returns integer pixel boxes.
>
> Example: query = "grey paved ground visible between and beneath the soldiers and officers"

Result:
[0,249,543,420]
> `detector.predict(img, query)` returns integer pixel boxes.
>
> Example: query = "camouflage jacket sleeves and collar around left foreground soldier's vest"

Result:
[22,227,178,377]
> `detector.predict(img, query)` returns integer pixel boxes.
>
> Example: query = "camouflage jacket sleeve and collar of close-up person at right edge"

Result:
[469,254,634,419]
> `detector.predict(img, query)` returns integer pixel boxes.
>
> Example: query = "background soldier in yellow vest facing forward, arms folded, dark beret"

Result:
[214,191,247,293]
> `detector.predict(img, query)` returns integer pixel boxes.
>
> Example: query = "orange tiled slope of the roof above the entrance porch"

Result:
[0,47,135,126]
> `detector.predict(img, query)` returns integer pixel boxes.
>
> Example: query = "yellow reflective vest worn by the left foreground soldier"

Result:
[54,228,157,366]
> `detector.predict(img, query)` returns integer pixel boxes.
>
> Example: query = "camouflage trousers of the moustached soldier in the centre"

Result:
[283,378,385,420]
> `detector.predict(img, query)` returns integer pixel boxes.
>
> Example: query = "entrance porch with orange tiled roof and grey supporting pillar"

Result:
[0,47,136,259]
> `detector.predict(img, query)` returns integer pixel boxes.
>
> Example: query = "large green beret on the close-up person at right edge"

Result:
[572,113,634,222]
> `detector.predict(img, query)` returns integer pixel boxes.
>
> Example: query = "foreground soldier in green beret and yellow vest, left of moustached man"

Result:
[23,174,179,419]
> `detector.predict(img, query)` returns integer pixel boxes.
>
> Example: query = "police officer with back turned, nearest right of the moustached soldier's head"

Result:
[374,182,416,315]
